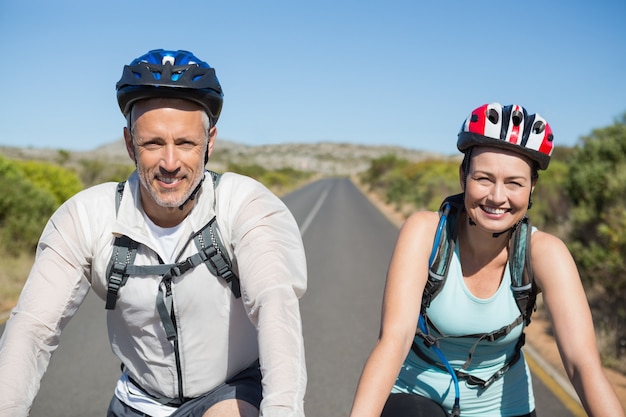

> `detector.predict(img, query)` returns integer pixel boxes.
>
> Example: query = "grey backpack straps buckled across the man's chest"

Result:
[105,171,241,308]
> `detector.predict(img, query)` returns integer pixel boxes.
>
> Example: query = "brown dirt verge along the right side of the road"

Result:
[353,178,626,409]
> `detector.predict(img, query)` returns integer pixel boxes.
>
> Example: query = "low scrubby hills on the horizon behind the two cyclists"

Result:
[0,138,457,175]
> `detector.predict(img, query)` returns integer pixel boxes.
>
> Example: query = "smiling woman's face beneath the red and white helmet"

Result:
[461,147,535,233]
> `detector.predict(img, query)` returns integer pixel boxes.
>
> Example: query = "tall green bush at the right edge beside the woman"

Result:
[566,114,626,355]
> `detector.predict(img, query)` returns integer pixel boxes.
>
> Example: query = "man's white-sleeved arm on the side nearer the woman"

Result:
[225,176,307,417]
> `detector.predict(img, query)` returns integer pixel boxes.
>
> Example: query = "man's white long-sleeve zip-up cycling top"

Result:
[0,173,306,417]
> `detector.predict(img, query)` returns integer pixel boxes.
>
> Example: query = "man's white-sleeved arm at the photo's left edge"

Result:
[0,196,89,417]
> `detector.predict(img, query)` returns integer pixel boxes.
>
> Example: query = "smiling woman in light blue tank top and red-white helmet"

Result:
[351,103,624,417]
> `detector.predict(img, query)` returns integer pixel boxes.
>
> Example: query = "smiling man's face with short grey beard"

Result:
[124,99,216,227]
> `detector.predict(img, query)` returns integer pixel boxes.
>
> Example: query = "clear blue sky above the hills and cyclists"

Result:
[0,0,626,154]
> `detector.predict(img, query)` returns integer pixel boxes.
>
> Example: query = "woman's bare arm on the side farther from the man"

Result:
[531,232,624,417]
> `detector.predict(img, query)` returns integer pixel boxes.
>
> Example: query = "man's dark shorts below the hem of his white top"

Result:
[107,361,263,417]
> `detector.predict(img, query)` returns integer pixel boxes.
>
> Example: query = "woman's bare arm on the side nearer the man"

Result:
[350,212,439,417]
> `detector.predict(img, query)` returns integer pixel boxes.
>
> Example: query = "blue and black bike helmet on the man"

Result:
[115,49,224,126]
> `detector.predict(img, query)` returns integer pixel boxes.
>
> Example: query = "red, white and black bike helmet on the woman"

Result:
[457,103,554,169]
